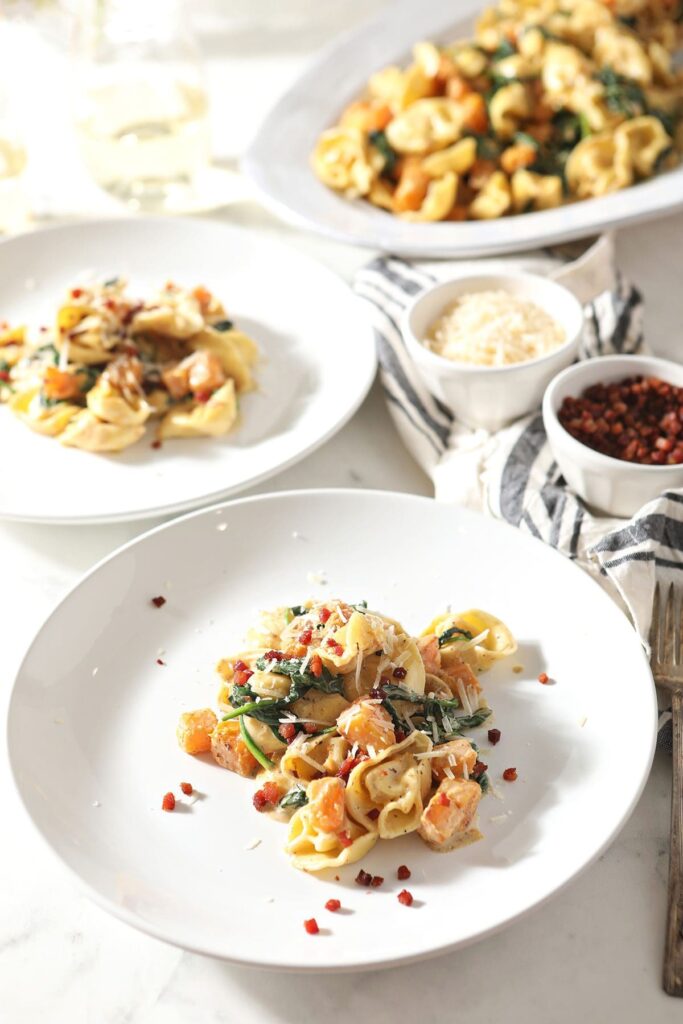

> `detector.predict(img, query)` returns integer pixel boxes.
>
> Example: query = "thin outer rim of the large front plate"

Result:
[3,487,658,975]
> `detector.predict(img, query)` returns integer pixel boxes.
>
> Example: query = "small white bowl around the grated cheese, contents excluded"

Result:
[401,273,584,431]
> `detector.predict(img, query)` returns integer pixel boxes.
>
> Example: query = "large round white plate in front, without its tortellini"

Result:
[9,490,656,971]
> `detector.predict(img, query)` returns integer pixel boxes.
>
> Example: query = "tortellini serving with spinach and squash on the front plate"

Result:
[178,600,516,871]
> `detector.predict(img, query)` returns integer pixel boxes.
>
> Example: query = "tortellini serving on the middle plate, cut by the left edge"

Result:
[0,278,258,452]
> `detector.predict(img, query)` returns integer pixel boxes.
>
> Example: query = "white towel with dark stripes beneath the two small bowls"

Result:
[354,234,683,745]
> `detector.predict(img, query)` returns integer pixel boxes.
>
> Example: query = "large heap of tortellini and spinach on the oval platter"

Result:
[312,0,683,221]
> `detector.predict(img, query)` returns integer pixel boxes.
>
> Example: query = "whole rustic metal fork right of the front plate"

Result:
[650,584,683,996]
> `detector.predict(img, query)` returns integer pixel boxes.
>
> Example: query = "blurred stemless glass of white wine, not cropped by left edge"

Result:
[74,0,211,212]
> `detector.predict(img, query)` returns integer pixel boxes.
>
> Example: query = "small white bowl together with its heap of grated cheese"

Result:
[401,273,584,431]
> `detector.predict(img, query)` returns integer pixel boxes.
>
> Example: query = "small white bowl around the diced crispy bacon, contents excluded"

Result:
[543,355,683,518]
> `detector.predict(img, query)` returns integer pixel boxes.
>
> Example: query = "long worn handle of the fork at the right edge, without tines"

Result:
[664,690,683,996]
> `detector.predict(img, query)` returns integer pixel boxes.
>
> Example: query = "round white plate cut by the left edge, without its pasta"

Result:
[0,218,376,522]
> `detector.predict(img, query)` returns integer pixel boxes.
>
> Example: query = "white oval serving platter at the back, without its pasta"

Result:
[245,0,683,258]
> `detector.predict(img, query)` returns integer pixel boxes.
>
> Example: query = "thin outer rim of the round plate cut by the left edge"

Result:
[0,214,378,526]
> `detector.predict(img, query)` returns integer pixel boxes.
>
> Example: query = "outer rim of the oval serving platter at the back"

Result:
[240,0,683,259]
